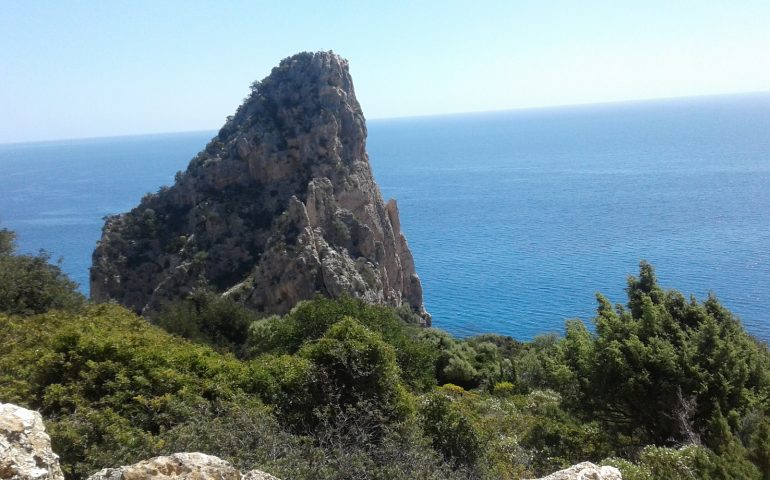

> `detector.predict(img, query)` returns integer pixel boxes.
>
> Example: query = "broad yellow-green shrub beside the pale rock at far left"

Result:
[0,305,261,478]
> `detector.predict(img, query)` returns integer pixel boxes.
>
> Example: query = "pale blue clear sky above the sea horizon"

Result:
[0,0,770,143]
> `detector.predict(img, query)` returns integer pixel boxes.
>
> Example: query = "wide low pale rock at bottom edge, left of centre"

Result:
[88,453,278,480]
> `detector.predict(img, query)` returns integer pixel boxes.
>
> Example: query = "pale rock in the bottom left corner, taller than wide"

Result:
[0,403,64,480]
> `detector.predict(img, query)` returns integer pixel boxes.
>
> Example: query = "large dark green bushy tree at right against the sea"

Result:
[561,262,770,448]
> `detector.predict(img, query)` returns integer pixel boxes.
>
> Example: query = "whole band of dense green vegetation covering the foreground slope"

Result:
[0,227,770,480]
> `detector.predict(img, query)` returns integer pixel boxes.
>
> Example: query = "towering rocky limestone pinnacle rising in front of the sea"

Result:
[91,52,430,323]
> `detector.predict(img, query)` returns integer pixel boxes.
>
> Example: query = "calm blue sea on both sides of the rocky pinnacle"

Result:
[0,93,770,341]
